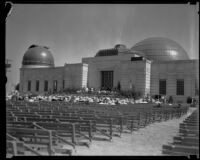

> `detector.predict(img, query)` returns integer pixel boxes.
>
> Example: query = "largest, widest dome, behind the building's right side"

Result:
[131,37,189,61]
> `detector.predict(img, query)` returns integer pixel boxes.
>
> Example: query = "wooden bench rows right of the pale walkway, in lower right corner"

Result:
[162,110,199,158]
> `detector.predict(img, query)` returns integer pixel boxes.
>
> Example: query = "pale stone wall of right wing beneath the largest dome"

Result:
[150,60,199,102]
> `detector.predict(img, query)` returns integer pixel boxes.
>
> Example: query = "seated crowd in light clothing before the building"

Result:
[6,90,173,105]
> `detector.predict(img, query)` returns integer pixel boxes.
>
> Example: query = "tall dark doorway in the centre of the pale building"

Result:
[101,71,113,90]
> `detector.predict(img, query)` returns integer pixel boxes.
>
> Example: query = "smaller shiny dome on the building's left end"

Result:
[22,45,54,67]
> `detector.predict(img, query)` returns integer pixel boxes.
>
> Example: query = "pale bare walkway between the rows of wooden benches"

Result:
[74,108,195,156]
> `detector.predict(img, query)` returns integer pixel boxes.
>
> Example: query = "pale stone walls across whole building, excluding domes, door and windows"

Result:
[20,53,199,102]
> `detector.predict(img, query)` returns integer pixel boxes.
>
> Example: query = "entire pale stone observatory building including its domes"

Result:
[20,37,199,102]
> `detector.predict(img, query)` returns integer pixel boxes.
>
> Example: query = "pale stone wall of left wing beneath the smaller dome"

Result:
[20,63,87,94]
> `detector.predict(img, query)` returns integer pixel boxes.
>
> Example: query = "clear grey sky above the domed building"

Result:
[5,4,199,93]
